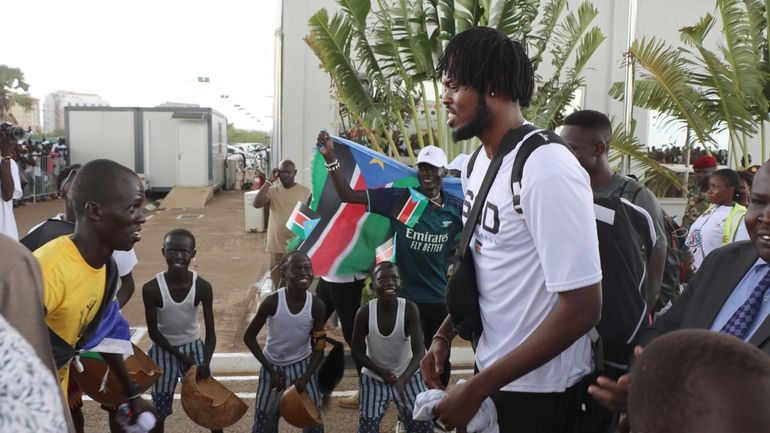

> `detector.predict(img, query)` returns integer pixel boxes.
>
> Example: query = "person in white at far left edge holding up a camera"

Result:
[0,123,24,240]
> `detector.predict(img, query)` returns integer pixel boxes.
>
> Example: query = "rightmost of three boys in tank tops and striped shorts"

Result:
[351,262,433,433]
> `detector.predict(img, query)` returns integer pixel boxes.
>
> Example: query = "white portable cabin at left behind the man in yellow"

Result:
[64,107,227,192]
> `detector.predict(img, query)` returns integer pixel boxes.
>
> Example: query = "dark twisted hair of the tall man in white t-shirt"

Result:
[436,27,535,107]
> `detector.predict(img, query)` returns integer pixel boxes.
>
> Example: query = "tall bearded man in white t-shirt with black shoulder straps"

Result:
[421,27,602,433]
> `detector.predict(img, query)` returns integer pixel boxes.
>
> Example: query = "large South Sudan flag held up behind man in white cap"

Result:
[289,137,462,275]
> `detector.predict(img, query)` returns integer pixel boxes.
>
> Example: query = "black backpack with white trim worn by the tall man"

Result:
[466,126,655,371]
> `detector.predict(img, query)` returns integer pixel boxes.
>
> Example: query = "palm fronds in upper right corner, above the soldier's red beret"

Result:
[610,0,770,172]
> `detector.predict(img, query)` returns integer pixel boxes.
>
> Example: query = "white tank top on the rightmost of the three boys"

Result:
[362,298,412,381]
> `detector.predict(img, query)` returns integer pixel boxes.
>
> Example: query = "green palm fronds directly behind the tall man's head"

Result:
[305,0,604,161]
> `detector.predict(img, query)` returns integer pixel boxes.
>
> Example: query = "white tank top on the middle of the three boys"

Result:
[262,287,313,365]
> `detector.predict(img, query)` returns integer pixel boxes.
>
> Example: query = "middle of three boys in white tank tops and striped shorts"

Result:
[243,251,326,433]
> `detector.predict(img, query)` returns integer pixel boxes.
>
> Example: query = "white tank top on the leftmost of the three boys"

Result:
[155,271,201,346]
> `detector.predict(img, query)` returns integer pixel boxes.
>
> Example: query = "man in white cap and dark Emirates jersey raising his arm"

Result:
[318,131,462,392]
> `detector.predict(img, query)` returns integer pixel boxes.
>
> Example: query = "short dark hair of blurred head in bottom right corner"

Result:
[628,329,770,433]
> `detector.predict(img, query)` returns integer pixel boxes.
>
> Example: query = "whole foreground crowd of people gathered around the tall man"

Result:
[0,27,770,433]
